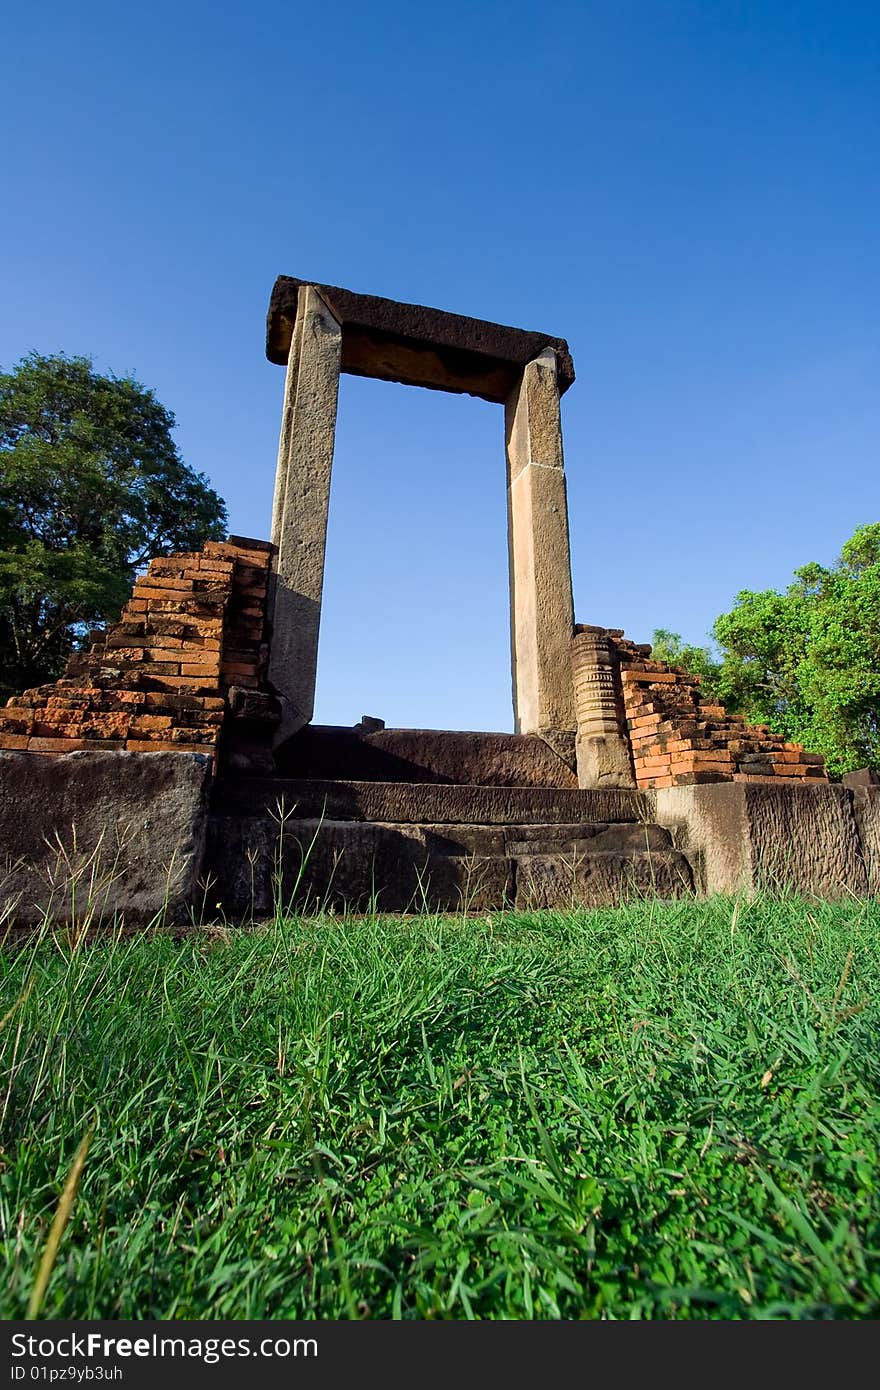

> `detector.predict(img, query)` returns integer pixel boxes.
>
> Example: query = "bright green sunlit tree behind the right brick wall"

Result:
[655,523,880,777]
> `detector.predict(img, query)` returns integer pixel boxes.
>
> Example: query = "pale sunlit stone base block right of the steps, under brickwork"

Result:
[648,783,867,898]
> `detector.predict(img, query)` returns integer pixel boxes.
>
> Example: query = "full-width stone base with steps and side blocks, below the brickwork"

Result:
[0,731,880,927]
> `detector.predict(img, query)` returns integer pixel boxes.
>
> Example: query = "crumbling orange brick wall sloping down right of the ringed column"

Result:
[597,628,827,790]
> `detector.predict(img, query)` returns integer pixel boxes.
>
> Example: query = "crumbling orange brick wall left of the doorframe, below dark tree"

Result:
[0,537,272,759]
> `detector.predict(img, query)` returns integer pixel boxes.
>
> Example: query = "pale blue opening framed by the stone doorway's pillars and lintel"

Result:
[314,375,513,733]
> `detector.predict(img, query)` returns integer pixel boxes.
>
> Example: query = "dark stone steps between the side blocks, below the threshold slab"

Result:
[206,777,694,919]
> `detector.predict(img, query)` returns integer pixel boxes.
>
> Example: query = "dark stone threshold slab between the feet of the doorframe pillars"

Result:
[275,724,577,788]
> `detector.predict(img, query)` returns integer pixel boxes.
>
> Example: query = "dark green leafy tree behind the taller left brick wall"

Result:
[0,353,227,695]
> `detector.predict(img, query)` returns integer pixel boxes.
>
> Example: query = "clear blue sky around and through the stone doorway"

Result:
[0,0,880,730]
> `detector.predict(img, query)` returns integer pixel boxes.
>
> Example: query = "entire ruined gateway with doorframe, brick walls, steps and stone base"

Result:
[0,277,880,924]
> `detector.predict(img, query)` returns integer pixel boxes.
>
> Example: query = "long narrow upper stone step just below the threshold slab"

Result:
[211,777,649,826]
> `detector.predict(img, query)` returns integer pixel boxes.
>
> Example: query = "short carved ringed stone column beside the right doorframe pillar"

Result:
[571,628,635,787]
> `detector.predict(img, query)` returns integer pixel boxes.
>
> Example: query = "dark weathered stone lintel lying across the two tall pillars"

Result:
[266,275,574,403]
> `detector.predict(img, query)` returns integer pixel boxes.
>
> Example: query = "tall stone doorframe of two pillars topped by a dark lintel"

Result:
[267,275,577,741]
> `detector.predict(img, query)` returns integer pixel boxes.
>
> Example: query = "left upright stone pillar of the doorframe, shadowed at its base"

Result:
[268,285,342,742]
